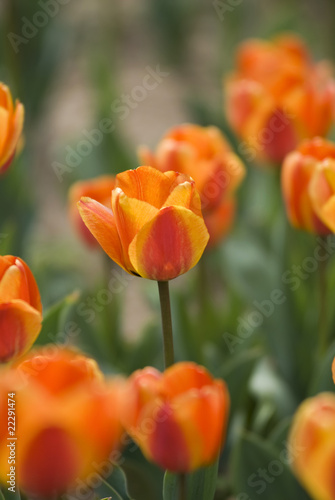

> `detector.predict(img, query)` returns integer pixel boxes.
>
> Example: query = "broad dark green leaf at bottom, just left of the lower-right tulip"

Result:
[232,433,309,500]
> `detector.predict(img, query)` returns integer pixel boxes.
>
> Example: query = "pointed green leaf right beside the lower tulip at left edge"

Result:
[36,291,79,345]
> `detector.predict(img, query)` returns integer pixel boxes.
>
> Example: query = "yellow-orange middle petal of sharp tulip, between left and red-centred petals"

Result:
[112,188,158,269]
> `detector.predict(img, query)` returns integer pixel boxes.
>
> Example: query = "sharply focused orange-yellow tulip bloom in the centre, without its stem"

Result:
[78,167,208,281]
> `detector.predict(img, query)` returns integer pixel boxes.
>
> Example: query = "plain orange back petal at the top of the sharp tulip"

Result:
[116,167,178,208]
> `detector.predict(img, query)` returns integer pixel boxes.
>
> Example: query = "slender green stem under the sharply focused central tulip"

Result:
[158,281,174,368]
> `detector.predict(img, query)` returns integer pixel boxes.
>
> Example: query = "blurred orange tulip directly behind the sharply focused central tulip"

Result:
[139,124,245,246]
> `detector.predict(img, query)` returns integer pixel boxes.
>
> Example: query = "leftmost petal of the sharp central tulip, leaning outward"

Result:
[78,197,128,272]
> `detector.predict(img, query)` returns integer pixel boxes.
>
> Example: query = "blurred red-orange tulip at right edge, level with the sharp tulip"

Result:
[282,137,335,234]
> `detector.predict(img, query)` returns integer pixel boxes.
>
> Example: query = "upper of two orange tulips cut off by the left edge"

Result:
[0,82,24,172]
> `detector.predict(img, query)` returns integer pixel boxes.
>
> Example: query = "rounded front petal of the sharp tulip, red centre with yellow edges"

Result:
[129,207,209,281]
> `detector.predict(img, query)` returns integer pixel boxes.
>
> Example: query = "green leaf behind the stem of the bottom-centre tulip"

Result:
[163,460,219,500]
